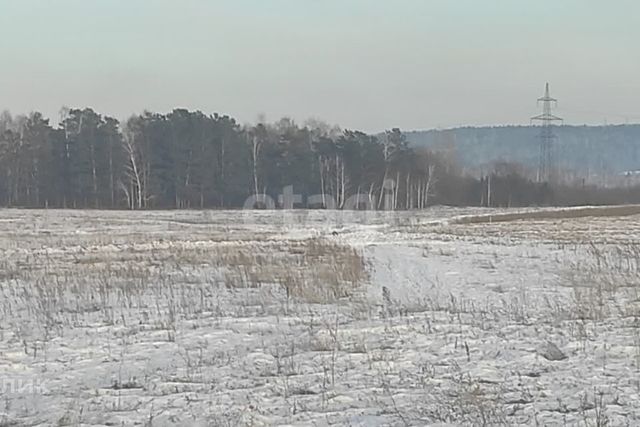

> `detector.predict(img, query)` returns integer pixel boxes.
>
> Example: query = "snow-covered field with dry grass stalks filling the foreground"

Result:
[0,208,640,426]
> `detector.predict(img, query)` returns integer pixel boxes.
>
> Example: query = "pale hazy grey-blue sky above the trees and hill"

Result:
[0,0,640,131]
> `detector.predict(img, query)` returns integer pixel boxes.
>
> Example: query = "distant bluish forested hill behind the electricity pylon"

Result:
[406,124,640,176]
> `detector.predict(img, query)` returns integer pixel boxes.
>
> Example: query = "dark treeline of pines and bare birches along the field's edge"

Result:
[0,108,637,209]
